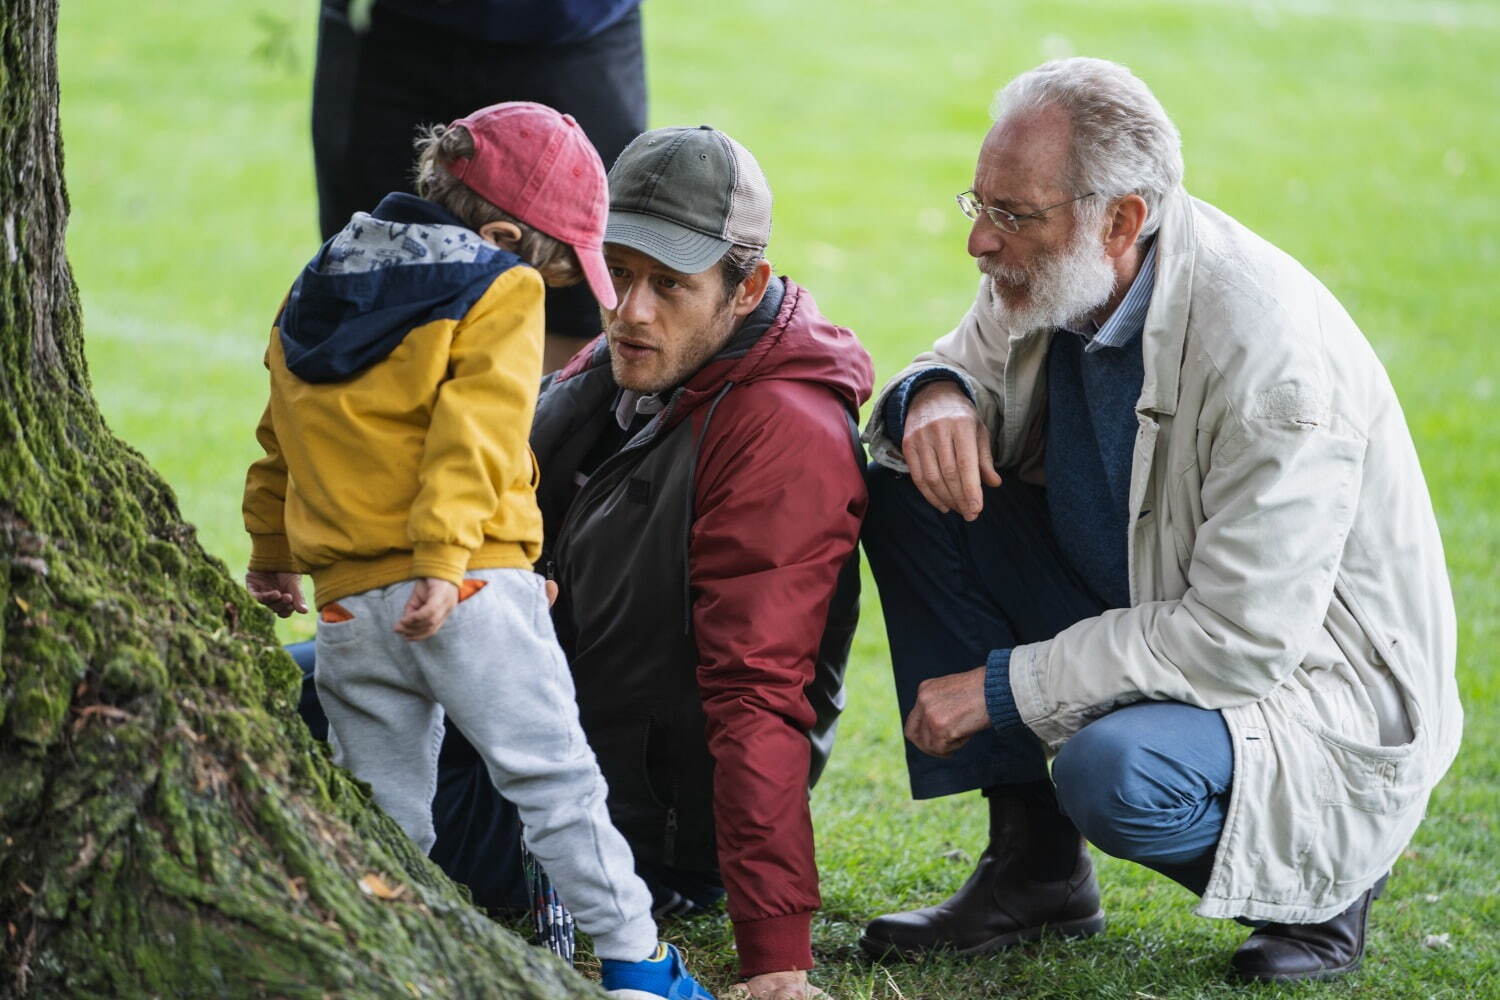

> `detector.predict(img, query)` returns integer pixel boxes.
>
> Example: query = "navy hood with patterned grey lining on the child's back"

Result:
[278,193,524,382]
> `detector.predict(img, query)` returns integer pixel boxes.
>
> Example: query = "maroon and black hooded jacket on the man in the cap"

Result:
[531,279,875,976]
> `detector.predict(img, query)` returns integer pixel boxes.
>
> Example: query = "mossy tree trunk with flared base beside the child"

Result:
[0,0,599,999]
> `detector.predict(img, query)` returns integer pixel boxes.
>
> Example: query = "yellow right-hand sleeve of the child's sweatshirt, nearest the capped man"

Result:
[408,267,543,583]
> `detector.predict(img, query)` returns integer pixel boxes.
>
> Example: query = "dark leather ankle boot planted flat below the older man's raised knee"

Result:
[860,784,1104,958]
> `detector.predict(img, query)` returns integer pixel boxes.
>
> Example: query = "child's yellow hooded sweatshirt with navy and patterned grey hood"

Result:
[243,195,543,609]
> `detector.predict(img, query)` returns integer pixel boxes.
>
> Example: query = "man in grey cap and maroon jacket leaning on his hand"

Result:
[531,126,873,999]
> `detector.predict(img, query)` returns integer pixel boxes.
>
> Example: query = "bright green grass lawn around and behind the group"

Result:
[59,0,1500,1000]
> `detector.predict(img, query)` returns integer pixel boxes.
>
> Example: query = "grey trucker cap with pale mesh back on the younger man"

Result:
[605,124,771,274]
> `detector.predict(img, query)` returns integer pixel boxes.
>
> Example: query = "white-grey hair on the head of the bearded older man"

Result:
[990,57,1182,240]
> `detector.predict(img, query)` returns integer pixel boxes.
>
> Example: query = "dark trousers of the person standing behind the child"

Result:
[312,4,647,337]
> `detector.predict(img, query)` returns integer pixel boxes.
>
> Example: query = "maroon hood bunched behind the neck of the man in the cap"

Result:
[557,277,875,423]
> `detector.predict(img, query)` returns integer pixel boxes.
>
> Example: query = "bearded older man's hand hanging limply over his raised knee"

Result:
[902,379,1001,520]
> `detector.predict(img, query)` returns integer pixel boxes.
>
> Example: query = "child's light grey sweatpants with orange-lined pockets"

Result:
[317,570,657,961]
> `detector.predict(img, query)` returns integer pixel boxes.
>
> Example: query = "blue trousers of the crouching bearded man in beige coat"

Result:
[863,465,1235,892]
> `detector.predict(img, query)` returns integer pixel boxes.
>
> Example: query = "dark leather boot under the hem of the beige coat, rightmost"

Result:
[1230,876,1386,982]
